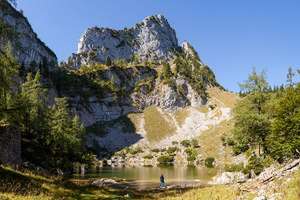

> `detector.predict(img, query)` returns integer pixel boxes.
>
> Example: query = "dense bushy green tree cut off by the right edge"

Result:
[267,84,300,161]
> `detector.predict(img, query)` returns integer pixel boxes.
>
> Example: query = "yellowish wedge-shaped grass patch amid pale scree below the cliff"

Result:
[144,106,176,142]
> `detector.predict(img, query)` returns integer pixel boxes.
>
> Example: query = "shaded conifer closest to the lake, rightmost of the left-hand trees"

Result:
[46,98,84,168]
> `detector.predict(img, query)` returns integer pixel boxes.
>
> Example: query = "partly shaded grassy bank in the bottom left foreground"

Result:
[0,167,147,200]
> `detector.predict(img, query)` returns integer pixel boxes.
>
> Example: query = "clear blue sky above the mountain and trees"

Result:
[18,0,300,91]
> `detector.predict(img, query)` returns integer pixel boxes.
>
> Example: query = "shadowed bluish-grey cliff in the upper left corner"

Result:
[0,0,57,68]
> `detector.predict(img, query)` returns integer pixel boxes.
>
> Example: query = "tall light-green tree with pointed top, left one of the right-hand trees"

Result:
[234,71,270,154]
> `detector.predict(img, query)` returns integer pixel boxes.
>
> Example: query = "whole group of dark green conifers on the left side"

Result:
[0,48,88,170]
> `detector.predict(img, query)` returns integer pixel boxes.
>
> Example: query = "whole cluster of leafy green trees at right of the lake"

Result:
[233,68,300,163]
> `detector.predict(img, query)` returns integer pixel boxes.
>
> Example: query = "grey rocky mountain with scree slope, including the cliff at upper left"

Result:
[0,1,235,163]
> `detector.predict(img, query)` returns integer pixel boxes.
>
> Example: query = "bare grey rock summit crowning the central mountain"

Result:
[69,15,178,68]
